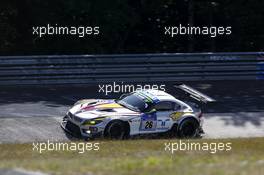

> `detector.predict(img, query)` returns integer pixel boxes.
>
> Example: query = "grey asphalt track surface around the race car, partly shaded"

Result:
[0,81,264,143]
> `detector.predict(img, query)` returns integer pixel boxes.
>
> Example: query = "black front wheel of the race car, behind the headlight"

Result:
[105,120,126,140]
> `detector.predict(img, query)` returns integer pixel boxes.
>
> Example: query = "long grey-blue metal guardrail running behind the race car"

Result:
[0,52,264,85]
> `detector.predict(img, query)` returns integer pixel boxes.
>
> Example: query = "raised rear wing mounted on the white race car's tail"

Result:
[174,84,216,103]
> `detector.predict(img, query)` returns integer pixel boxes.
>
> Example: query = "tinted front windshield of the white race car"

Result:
[117,94,149,112]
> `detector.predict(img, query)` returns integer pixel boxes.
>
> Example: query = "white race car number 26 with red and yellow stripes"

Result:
[61,84,214,139]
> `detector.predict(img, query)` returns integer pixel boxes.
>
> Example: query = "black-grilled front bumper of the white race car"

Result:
[61,115,103,138]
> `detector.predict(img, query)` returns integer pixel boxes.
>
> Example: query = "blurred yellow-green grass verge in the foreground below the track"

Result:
[0,138,264,175]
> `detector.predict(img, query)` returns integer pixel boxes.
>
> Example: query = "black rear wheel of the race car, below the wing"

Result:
[178,118,199,138]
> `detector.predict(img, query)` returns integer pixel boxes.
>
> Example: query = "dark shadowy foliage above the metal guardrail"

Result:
[0,0,264,55]
